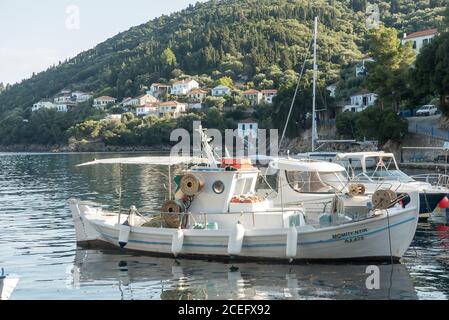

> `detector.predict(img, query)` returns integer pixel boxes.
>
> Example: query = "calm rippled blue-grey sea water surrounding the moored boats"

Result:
[0,154,449,299]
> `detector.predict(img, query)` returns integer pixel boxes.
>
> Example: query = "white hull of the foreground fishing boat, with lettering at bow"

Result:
[71,200,418,261]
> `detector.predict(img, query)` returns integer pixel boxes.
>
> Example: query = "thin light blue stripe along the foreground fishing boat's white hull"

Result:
[102,217,417,248]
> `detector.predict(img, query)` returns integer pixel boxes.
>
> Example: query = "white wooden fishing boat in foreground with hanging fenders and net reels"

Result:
[70,129,419,262]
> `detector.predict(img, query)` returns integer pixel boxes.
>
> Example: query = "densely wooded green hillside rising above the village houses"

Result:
[0,0,444,143]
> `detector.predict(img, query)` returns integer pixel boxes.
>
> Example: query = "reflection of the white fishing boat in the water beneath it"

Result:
[71,249,417,300]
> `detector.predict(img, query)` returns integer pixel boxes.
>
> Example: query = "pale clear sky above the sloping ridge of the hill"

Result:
[0,0,204,84]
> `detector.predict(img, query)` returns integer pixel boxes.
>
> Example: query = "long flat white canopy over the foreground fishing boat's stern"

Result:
[77,156,214,167]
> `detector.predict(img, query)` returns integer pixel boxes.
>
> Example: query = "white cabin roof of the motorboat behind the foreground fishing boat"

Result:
[270,159,346,172]
